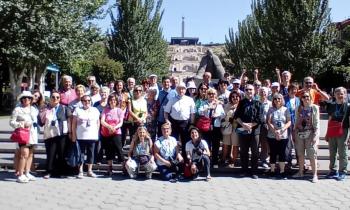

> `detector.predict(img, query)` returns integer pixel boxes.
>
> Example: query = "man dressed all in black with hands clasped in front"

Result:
[234,84,261,179]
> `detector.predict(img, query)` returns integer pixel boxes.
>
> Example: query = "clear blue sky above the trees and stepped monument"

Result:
[97,0,350,43]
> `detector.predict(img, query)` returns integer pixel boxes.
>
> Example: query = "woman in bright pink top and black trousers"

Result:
[101,95,124,176]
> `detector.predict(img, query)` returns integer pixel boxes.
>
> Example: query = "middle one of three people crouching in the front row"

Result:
[153,123,184,182]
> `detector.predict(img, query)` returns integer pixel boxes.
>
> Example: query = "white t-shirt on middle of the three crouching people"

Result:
[154,136,177,165]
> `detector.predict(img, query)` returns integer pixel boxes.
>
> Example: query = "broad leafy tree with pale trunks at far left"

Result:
[0,0,106,103]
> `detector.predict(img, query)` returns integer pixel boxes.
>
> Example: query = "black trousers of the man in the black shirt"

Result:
[238,135,259,174]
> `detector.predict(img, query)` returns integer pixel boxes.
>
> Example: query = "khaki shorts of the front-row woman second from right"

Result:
[295,132,318,159]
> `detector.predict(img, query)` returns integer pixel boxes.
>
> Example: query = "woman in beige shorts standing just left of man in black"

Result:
[221,91,241,168]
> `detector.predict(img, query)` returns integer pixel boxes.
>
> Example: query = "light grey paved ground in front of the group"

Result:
[0,116,350,210]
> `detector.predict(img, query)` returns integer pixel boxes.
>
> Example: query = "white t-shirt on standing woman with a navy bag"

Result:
[73,107,100,140]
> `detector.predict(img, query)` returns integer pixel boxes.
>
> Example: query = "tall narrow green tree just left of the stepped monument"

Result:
[107,0,168,80]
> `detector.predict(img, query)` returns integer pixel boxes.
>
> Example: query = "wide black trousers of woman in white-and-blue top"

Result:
[45,135,66,175]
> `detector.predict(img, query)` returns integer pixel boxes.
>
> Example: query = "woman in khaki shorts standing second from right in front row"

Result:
[293,92,320,183]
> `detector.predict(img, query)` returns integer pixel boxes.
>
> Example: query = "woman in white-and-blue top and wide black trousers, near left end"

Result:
[40,90,68,179]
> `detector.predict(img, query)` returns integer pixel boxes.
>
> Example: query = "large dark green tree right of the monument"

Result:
[226,0,341,80]
